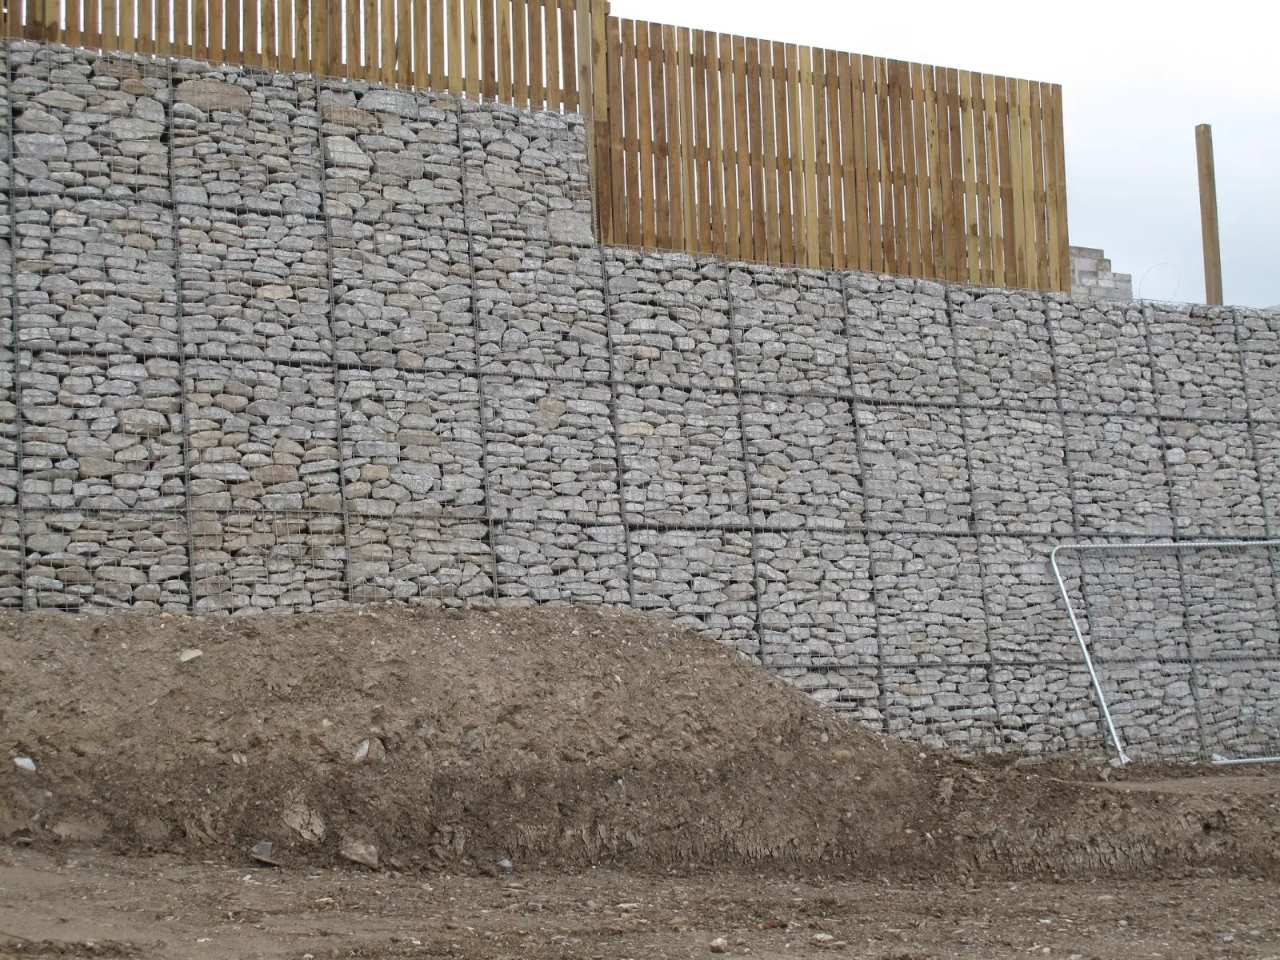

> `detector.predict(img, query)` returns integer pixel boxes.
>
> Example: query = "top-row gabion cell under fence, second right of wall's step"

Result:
[728,266,850,394]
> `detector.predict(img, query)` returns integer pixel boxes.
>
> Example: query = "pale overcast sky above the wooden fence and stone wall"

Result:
[613,0,1280,306]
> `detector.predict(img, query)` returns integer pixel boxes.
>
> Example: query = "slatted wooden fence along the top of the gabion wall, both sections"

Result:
[0,0,1070,289]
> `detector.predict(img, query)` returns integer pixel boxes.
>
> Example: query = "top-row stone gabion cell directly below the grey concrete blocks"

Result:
[1047,294,1156,416]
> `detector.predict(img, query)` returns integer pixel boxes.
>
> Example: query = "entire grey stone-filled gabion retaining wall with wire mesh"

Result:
[0,35,1280,755]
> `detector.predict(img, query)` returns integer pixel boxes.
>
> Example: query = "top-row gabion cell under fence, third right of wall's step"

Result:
[845,274,960,402]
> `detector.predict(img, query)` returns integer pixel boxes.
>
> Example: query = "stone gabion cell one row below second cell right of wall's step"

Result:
[742,393,863,530]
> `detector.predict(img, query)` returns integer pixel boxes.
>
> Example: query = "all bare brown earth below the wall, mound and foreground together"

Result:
[0,608,1280,960]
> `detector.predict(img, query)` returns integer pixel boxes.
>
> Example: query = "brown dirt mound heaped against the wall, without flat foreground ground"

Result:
[0,607,1280,876]
